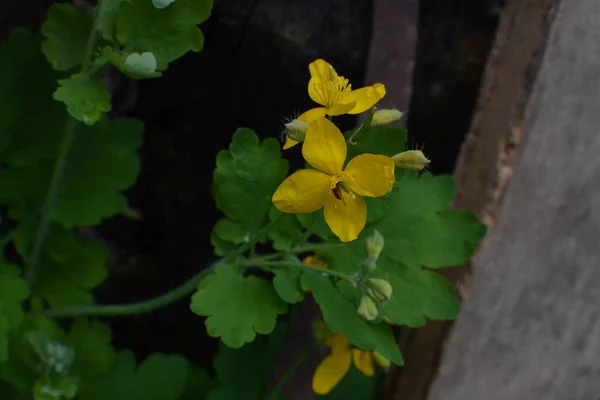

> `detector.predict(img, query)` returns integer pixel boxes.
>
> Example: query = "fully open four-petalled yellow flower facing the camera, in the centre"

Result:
[272,118,394,242]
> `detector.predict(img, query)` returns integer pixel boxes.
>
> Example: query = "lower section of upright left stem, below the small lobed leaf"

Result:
[25,118,77,292]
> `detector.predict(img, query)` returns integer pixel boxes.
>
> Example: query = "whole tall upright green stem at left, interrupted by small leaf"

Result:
[25,0,102,292]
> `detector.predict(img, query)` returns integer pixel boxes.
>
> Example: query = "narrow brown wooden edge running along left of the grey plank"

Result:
[386,0,554,400]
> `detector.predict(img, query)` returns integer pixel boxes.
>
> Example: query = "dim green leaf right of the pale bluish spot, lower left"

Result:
[64,318,116,378]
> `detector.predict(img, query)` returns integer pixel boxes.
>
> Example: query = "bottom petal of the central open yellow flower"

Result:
[325,190,367,242]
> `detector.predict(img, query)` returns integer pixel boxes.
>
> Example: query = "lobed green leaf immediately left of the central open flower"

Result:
[212,128,288,253]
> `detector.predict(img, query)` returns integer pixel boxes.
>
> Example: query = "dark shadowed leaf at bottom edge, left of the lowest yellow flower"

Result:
[207,323,287,400]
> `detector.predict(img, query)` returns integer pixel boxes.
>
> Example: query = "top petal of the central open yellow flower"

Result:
[302,118,347,175]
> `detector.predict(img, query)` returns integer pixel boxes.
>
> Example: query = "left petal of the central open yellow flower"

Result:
[272,169,331,213]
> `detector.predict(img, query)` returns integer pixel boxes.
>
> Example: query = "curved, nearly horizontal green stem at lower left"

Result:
[42,260,221,318]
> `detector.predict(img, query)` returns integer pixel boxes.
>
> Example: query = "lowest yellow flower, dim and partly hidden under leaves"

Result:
[312,332,390,395]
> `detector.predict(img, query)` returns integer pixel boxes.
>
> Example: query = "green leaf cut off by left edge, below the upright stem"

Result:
[0,263,29,363]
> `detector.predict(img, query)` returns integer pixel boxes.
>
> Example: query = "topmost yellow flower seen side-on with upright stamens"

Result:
[283,59,385,149]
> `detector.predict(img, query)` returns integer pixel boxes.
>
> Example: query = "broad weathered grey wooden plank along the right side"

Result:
[429,0,600,400]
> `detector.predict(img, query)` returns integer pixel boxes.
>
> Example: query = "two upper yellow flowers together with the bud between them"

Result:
[272,60,395,242]
